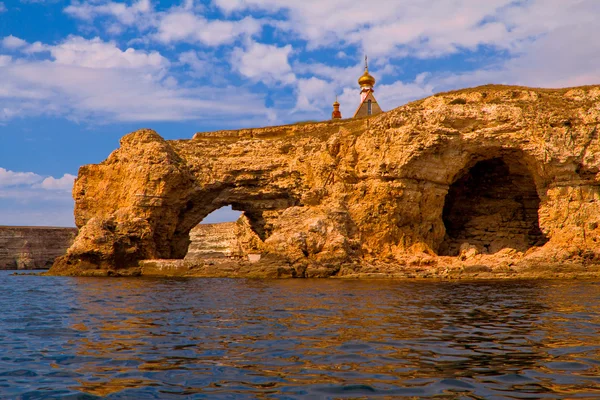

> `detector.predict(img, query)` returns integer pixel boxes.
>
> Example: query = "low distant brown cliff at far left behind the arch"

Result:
[0,226,77,269]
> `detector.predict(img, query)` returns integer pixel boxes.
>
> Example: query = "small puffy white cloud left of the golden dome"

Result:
[231,41,296,84]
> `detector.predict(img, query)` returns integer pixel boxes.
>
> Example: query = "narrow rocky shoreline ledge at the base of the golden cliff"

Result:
[39,260,600,281]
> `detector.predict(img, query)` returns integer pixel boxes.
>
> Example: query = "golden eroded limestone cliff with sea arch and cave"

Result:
[51,86,600,276]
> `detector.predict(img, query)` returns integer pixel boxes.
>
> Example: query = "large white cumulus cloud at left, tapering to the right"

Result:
[0,36,267,121]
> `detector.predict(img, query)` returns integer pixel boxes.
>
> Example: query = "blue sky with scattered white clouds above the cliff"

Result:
[0,0,600,226]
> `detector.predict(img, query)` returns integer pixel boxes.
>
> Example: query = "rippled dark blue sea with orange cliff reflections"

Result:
[0,273,600,399]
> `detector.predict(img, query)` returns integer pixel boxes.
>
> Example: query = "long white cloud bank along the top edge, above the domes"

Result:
[215,0,600,64]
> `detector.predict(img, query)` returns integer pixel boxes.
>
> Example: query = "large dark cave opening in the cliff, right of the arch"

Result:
[439,157,547,256]
